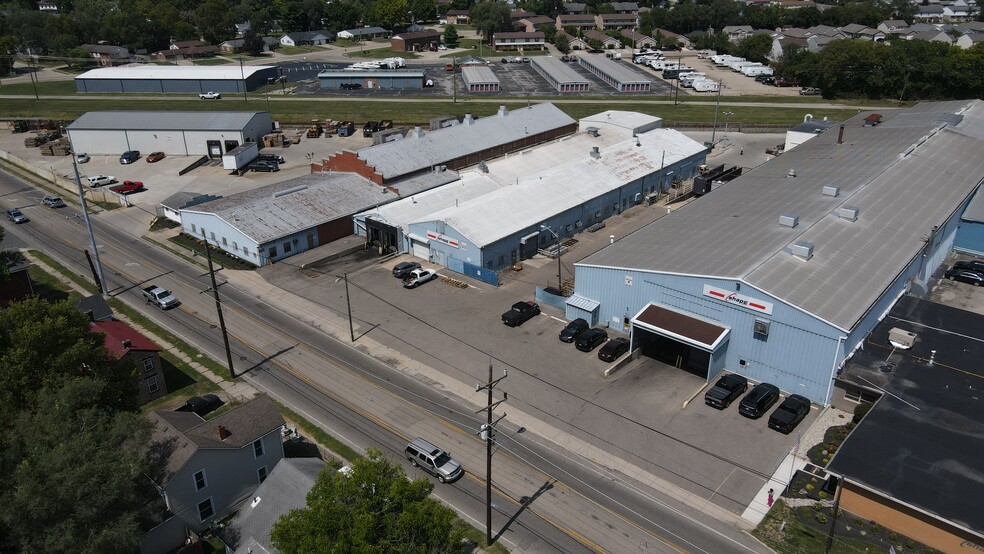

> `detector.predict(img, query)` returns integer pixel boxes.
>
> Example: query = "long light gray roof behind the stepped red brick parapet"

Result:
[358,103,574,179]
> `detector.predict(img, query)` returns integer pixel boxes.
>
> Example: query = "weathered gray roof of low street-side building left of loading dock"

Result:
[182,173,399,244]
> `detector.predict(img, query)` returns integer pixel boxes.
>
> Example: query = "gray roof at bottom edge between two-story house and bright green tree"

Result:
[218,458,331,554]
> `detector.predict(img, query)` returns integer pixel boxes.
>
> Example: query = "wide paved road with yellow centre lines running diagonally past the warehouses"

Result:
[0,162,764,552]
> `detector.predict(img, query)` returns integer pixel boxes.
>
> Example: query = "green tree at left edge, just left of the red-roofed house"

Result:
[0,298,137,420]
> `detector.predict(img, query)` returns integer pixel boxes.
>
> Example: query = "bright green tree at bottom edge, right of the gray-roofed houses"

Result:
[270,449,462,554]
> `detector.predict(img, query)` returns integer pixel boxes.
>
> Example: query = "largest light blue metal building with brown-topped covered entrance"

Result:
[566,101,984,404]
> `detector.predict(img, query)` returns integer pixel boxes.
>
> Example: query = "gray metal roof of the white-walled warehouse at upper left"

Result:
[66,110,260,131]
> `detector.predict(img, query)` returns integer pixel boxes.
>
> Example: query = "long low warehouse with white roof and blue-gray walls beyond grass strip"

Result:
[75,65,278,94]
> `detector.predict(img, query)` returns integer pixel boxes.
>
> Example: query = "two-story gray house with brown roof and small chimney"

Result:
[150,394,284,532]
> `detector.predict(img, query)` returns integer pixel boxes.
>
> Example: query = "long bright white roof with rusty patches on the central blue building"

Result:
[425,129,705,247]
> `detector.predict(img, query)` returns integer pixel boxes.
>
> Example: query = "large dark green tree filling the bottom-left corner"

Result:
[0,376,156,554]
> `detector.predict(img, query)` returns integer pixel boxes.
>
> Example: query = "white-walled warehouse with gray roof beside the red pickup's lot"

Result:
[65,111,273,157]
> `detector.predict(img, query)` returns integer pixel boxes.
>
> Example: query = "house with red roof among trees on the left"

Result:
[89,320,167,406]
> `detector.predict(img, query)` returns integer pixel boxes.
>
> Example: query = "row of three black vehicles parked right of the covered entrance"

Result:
[704,374,810,435]
